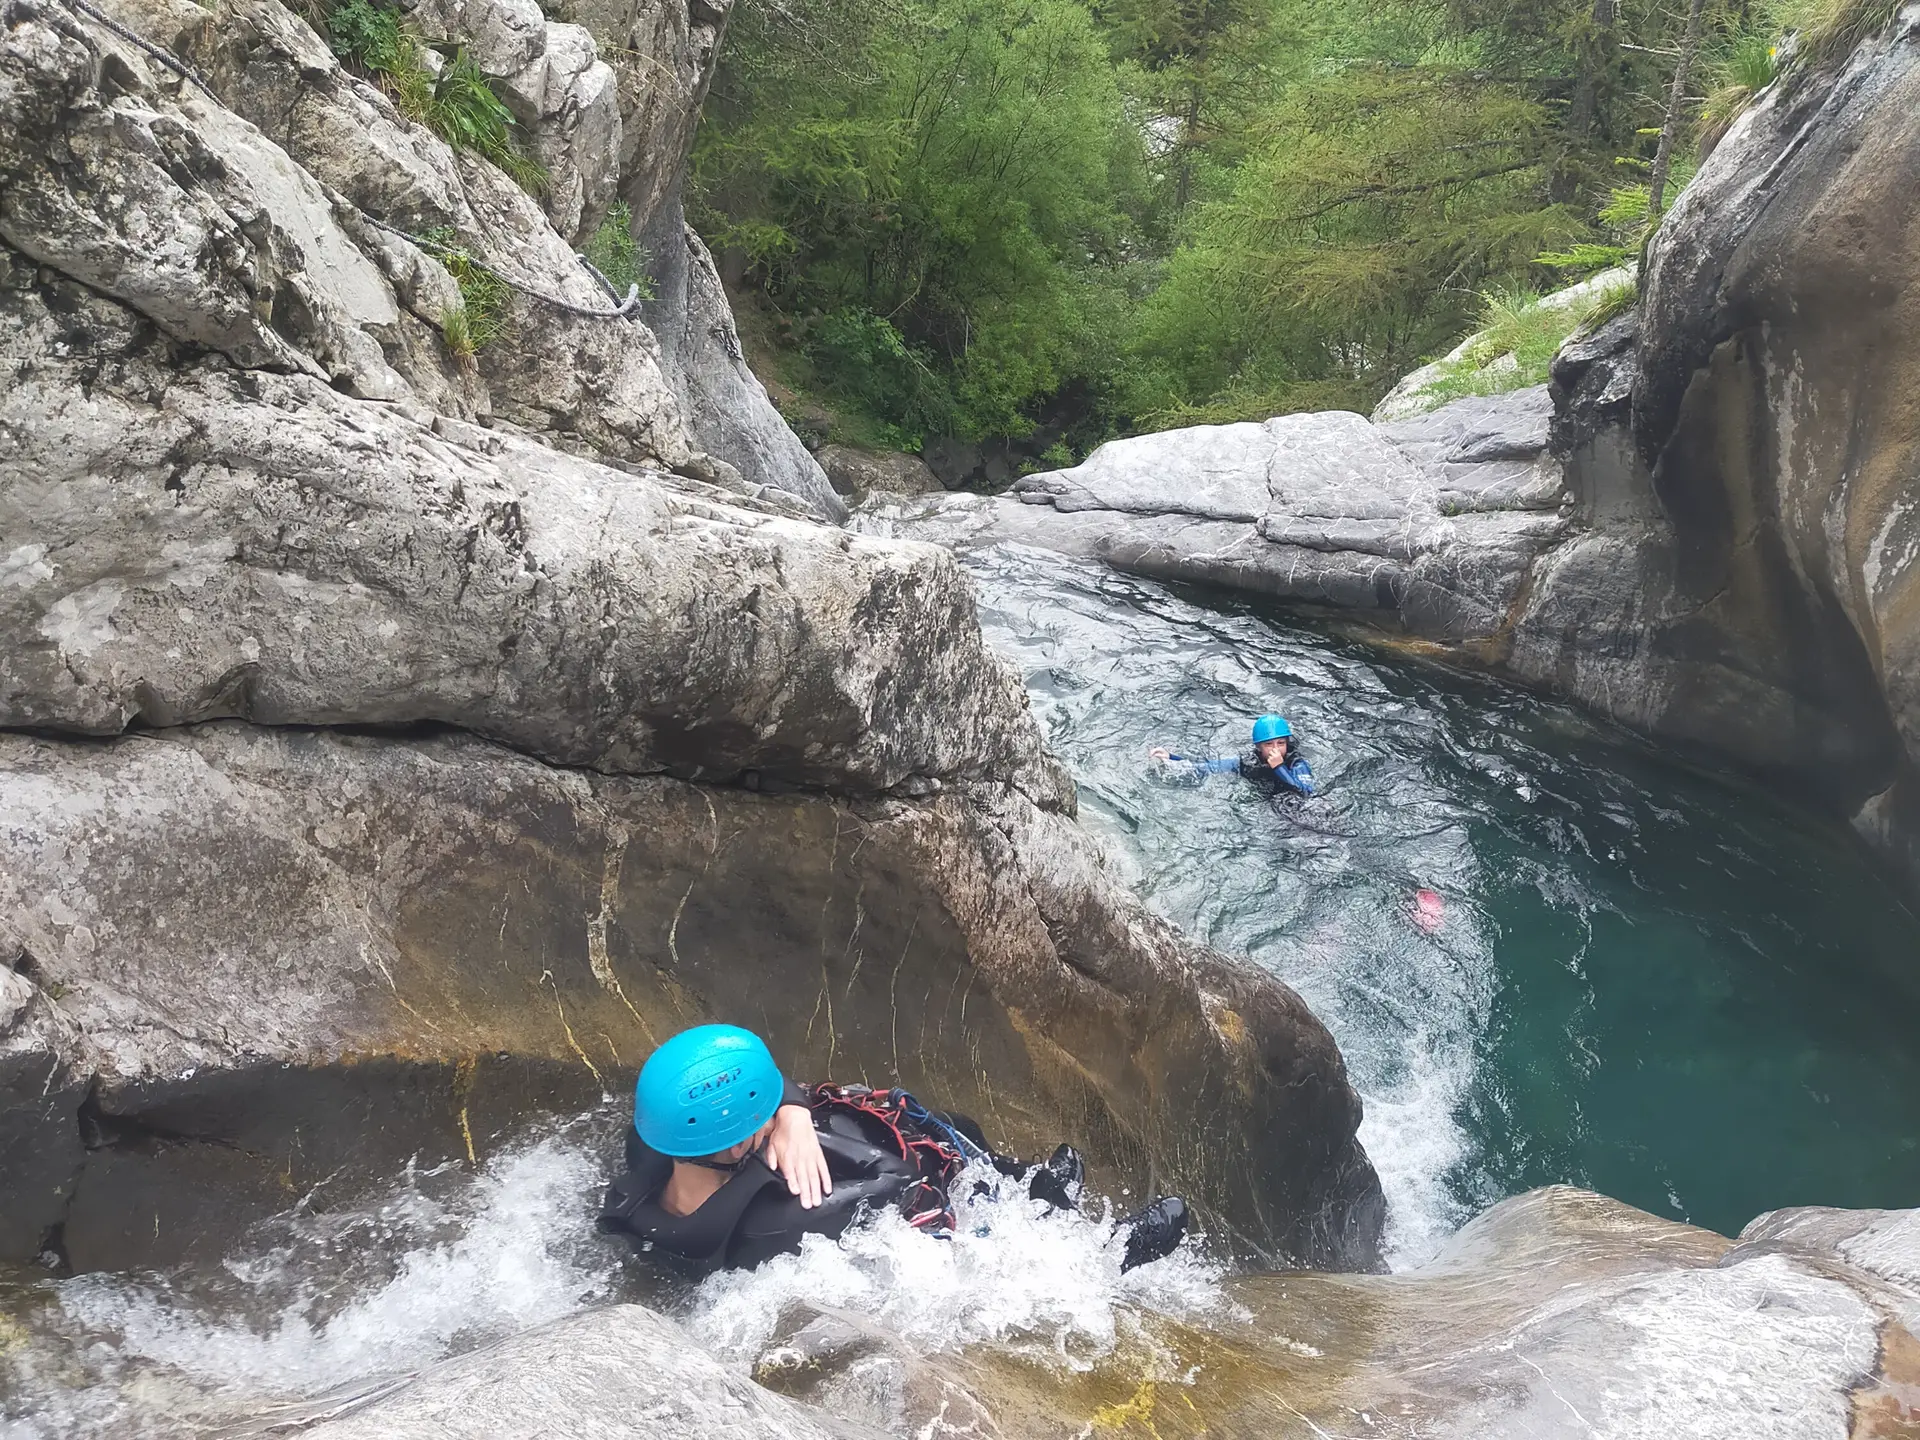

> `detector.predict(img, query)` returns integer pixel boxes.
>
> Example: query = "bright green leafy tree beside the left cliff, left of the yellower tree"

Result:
[695,0,1144,445]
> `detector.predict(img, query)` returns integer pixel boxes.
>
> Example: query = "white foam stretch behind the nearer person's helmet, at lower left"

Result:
[0,1121,620,1436]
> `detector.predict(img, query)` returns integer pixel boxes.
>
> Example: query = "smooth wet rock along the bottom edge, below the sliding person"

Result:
[240,1188,1920,1440]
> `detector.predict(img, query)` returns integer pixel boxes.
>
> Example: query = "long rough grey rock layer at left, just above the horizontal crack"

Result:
[0,273,1071,804]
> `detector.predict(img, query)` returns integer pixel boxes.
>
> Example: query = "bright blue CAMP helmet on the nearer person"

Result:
[634,1025,785,1156]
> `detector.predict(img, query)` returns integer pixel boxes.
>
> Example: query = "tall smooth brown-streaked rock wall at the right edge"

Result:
[1632,16,1920,877]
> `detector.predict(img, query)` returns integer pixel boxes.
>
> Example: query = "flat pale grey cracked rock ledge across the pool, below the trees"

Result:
[856,386,1569,647]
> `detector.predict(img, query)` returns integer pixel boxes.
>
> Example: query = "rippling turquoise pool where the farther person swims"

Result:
[970,549,1920,1261]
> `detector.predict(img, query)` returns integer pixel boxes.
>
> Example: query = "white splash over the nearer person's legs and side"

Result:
[687,1165,1229,1369]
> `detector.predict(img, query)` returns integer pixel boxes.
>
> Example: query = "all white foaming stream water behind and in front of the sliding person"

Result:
[0,1112,1223,1440]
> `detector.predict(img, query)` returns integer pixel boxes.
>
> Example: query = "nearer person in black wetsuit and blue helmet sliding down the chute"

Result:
[599,1025,1187,1273]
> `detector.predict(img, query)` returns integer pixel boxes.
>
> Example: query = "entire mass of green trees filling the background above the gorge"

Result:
[693,0,1882,451]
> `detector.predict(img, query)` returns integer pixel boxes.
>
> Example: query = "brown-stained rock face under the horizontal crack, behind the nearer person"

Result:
[0,724,1380,1269]
